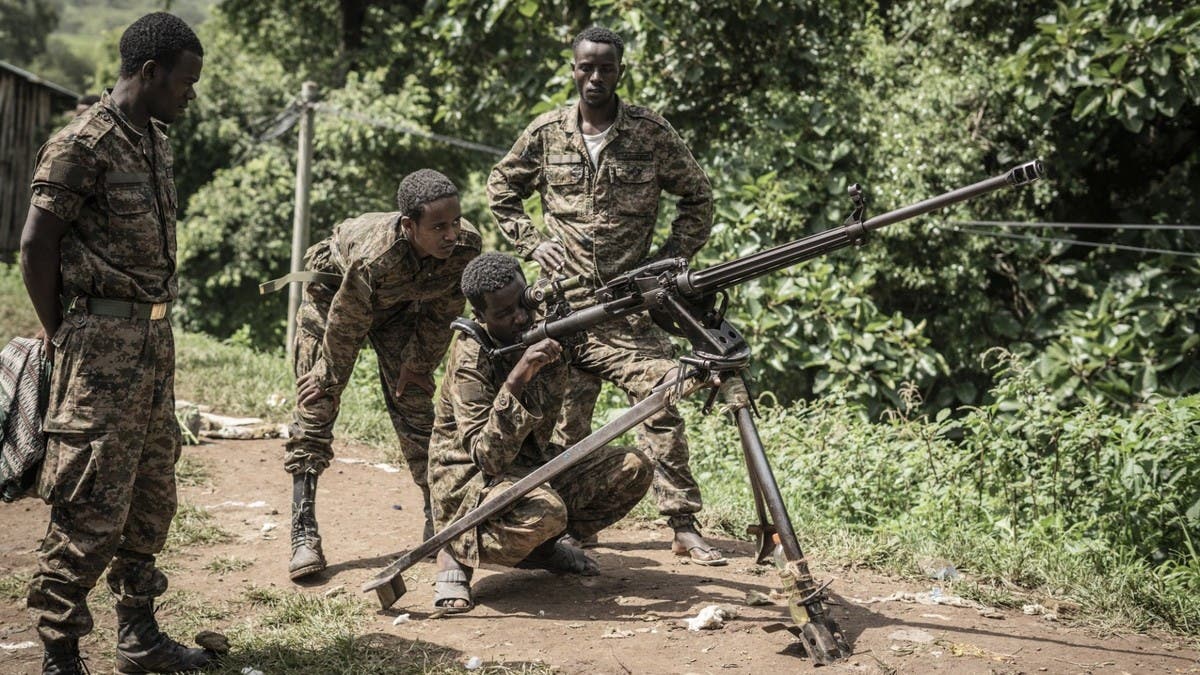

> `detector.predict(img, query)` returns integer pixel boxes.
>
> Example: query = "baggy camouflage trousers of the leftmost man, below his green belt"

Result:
[29,311,180,643]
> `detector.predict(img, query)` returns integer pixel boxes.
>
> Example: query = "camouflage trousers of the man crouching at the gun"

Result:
[451,446,653,567]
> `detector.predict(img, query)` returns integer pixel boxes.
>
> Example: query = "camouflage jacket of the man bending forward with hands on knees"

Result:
[298,213,482,392]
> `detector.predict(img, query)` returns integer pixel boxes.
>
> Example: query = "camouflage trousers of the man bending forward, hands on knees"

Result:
[283,306,433,490]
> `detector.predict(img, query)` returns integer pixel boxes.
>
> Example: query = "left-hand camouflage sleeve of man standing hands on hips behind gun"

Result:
[487,130,546,258]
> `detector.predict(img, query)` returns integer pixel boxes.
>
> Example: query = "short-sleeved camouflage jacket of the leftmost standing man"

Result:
[30,91,178,303]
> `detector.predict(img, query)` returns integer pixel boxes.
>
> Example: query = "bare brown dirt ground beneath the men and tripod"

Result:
[0,441,1200,675]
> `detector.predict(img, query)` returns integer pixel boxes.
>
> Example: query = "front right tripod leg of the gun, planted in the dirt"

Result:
[722,377,850,664]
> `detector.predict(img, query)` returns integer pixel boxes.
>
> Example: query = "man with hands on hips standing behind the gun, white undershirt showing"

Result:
[487,28,725,565]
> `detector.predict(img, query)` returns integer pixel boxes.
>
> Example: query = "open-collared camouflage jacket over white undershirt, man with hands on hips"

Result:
[487,97,713,281]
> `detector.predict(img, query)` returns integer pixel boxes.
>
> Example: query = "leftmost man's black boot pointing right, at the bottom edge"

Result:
[116,604,216,673]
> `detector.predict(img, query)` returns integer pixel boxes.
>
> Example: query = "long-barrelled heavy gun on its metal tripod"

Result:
[362,161,1044,664]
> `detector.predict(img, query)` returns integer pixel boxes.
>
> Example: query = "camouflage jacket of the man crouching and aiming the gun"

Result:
[430,338,568,567]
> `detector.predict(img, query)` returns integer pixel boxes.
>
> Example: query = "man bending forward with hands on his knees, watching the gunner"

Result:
[283,169,481,579]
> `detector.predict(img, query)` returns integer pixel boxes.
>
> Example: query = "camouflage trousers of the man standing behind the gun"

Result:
[554,313,702,515]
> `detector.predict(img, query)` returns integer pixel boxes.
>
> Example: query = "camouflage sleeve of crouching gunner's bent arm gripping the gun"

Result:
[443,357,541,476]
